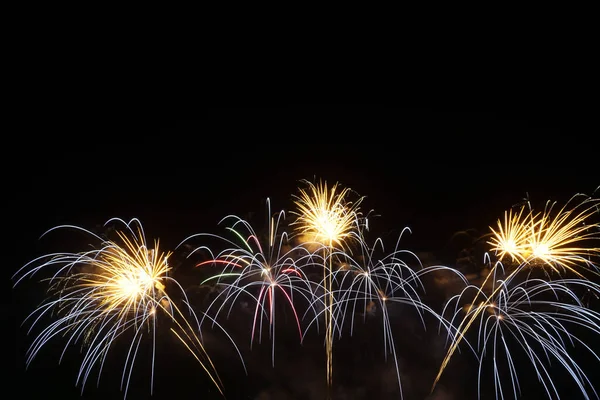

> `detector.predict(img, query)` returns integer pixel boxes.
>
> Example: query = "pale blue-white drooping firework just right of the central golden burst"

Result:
[302,228,467,398]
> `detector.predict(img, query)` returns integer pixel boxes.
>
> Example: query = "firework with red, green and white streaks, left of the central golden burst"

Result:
[180,199,315,365]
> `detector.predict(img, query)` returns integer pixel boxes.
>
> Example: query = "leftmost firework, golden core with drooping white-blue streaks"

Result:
[13,218,223,397]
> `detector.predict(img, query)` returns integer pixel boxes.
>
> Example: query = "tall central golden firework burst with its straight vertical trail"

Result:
[291,179,368,398]
